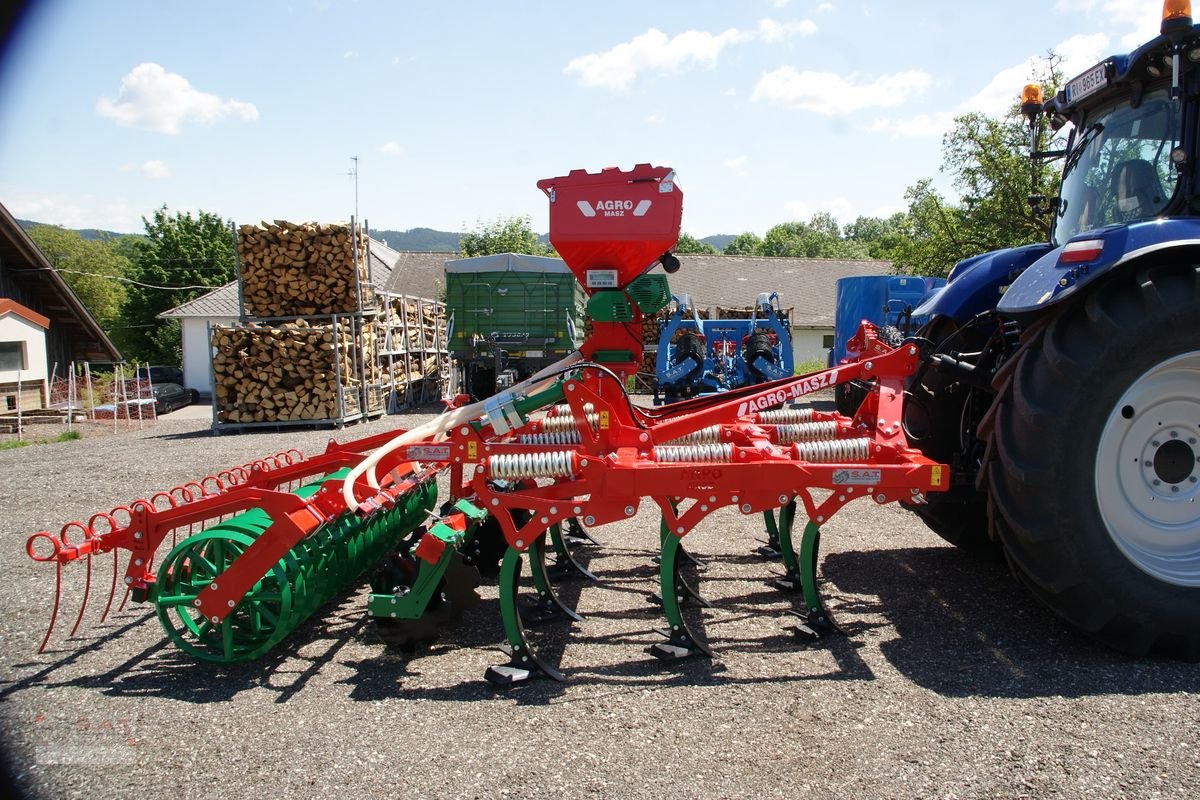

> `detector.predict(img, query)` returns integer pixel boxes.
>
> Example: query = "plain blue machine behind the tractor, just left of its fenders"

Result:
[829,275,946,367]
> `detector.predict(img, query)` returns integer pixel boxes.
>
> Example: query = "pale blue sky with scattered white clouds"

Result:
[0,0,1162,236]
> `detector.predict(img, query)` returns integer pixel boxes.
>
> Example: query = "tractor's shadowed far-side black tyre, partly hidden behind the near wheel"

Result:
[904,317,998,558]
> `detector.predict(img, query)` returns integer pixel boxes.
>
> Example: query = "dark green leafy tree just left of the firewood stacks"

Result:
[115,206,238,363]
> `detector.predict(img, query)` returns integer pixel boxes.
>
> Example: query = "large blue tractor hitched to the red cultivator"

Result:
[904,0,1200,660]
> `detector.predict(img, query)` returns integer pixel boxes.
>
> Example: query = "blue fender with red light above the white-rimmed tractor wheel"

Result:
[997,218,1200,319]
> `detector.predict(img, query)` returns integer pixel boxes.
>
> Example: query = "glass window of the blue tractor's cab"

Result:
[1055,90,1180,245]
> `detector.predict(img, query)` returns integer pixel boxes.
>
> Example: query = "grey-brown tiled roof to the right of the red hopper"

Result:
[668,255,892,327]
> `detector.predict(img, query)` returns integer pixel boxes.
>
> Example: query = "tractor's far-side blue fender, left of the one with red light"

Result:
[912,242,1051,324]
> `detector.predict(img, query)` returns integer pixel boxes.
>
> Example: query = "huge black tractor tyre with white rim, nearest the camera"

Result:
[980,264,1200,661]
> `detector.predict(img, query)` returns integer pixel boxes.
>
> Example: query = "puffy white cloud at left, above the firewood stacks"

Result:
[96,62,258,133]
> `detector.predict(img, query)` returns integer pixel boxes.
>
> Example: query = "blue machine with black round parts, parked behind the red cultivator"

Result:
[654,291,796,405]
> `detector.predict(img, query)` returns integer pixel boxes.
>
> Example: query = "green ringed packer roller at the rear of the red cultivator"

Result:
[150,469,437,663]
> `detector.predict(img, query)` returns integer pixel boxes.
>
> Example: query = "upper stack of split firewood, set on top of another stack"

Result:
[238,219,373,319]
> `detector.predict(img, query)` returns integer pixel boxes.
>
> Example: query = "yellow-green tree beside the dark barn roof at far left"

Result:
[29,225,130,332]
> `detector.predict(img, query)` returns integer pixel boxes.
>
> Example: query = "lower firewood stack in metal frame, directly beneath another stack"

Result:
[211,320,383,423]
